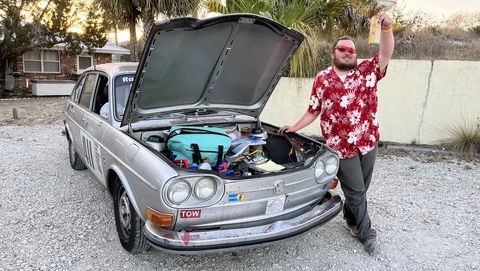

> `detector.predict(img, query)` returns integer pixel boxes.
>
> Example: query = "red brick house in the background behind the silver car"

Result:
[5,43,130,96]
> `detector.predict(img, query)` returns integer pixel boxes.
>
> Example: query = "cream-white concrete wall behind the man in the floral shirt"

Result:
[262,60,480,144]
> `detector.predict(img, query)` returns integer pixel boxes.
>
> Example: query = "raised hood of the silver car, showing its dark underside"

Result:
[122,14,304,126]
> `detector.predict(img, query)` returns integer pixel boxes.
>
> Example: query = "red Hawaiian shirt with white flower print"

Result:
[308,53,386,159]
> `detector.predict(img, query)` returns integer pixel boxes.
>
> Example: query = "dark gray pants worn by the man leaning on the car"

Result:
[337,148,377,241]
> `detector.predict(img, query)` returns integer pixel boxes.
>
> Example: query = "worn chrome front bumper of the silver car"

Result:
[145,192,342,254]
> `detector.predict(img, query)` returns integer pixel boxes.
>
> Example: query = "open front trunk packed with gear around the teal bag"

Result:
[133,121,326,179]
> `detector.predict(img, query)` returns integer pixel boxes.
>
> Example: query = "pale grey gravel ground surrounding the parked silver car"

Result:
[0,98,480,271]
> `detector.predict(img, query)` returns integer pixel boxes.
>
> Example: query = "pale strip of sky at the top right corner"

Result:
[397,0,480,17]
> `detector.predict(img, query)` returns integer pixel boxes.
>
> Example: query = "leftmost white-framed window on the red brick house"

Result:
[23,50,60,73]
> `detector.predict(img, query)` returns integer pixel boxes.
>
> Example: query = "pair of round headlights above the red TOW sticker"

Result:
[167,177,217,204]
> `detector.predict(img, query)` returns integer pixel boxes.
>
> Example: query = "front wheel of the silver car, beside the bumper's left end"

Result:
[113,180,149,254]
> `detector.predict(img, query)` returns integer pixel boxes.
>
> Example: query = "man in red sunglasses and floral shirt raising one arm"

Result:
[280,15,394,255]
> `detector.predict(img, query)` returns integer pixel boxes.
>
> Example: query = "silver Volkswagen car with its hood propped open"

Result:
[65,14,342,254]
